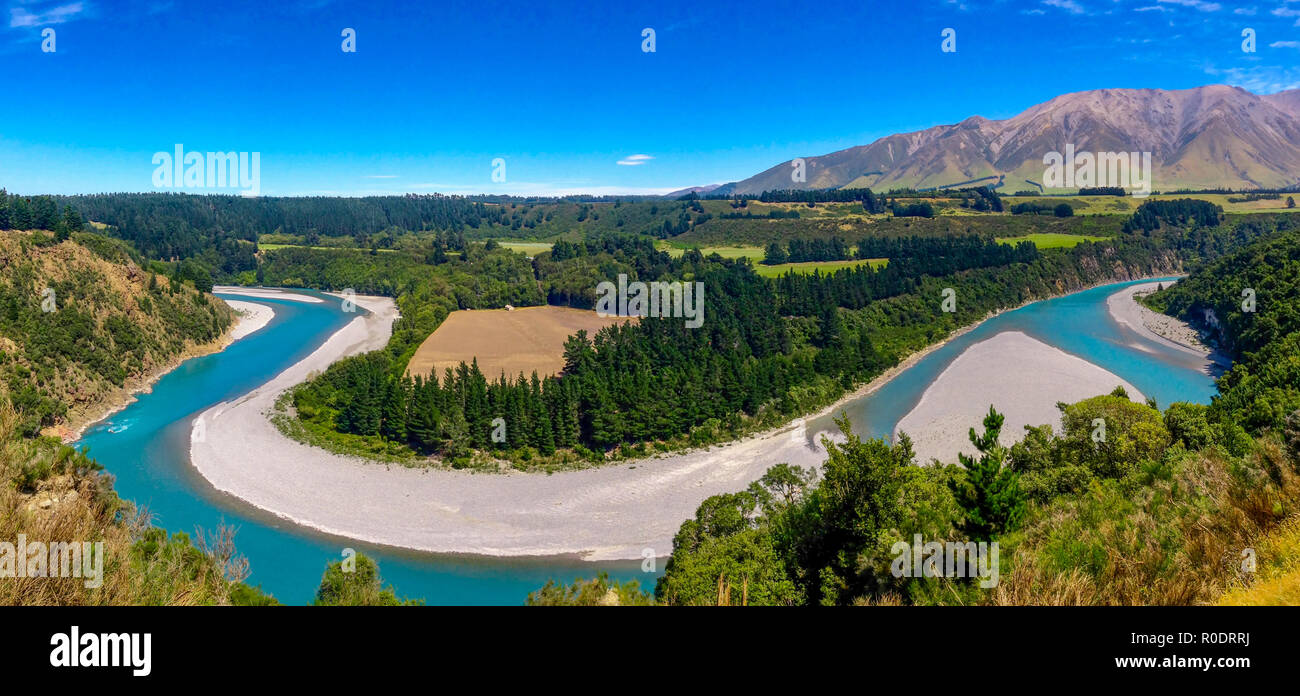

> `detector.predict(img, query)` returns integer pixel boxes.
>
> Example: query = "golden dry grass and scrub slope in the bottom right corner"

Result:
[993,438,1300,605]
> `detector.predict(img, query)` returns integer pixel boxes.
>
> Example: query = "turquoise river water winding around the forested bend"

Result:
[77,284,1214,605]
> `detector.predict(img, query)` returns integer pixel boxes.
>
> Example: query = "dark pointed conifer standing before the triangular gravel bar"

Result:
[952,406,1024,541]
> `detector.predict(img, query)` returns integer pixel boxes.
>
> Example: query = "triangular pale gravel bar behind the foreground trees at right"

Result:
[896,332,1145,463]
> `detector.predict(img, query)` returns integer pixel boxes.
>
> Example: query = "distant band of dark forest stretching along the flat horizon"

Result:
[43,187,1045,282]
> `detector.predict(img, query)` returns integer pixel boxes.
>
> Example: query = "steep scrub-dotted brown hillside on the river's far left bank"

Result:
[0,230,235,437]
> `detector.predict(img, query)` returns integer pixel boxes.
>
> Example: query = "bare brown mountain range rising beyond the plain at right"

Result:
[719,85,1300,194]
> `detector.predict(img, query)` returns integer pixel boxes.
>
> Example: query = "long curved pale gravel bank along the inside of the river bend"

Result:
[190,274,1190,561]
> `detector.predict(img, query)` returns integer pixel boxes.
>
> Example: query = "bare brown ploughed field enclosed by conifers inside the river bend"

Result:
[407,307,634,380]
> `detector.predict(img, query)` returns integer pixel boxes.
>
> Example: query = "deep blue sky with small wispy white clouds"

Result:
[0,0,1300,195]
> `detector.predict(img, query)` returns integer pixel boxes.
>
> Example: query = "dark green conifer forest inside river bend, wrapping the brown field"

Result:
[284,218,1206,466]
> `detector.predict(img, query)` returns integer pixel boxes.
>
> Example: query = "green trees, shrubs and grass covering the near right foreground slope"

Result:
[529,223,1300,605]
